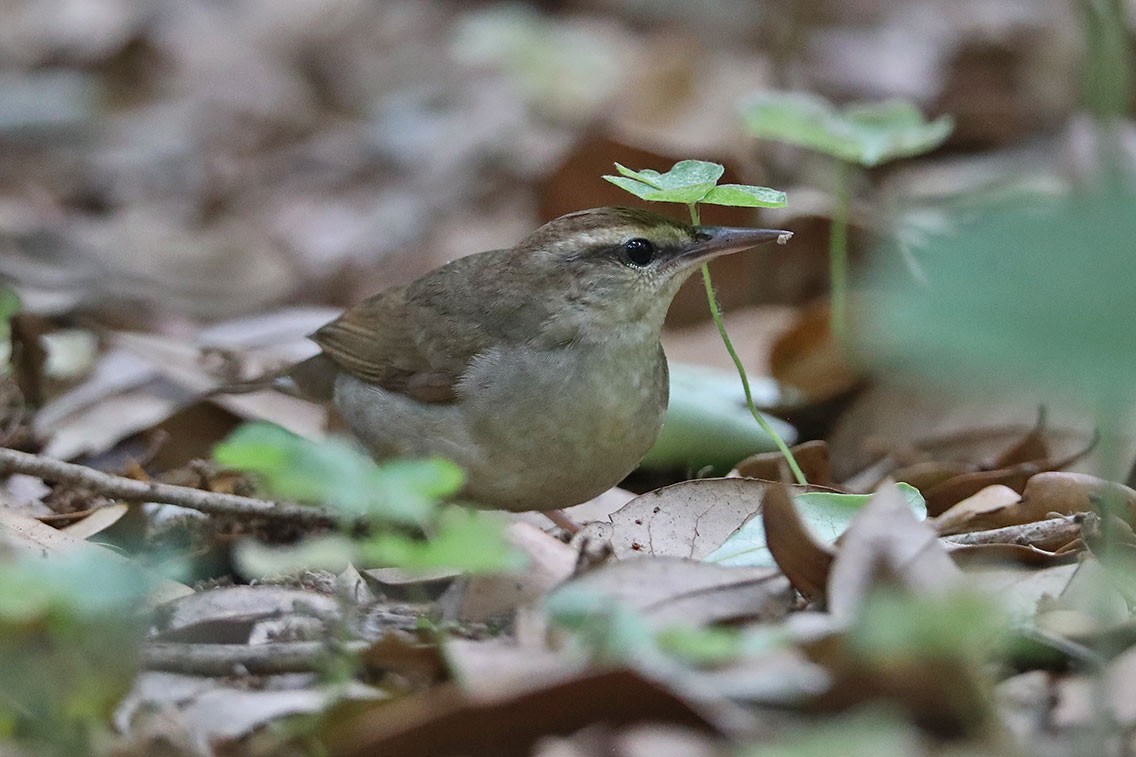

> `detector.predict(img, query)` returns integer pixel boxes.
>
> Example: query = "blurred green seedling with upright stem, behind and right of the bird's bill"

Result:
[742,91,954,346]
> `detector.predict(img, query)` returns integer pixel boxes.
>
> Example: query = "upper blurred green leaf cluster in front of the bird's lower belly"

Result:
[214,423,463,524]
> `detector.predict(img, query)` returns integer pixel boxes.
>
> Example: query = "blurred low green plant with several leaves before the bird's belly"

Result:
[214,423,520,575]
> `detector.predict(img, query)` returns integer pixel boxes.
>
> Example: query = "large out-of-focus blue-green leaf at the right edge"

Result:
[858,186,1136,406]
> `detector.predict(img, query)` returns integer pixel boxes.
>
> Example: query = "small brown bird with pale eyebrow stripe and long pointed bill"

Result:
[240,208,791,510]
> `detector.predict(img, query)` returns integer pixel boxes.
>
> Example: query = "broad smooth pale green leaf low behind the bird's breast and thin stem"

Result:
[641,363,796,472]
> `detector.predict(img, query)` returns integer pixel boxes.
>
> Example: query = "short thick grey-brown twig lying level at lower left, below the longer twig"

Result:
[142,641,369,675]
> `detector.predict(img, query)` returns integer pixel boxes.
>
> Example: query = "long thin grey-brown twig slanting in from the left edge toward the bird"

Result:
[0,449,343,526]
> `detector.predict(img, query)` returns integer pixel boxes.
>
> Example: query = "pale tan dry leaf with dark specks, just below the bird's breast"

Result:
[611,479,768,559]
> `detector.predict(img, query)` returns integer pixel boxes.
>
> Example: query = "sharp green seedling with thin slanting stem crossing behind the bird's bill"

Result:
[604,160,808,486]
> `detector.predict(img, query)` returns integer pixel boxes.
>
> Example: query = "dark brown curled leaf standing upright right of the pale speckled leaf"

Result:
[761,479,835,601]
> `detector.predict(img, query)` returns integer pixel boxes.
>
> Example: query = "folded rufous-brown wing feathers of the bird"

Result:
[311,286,463,402]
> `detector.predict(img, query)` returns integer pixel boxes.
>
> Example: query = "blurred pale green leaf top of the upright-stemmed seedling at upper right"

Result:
[742,91,954,167]
